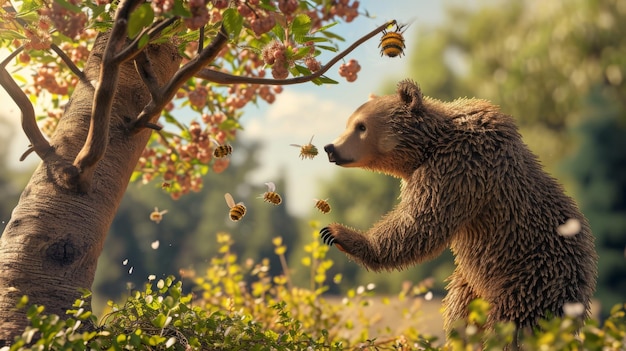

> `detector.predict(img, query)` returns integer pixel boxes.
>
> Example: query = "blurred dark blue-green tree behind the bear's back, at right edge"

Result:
[561,87,626,314]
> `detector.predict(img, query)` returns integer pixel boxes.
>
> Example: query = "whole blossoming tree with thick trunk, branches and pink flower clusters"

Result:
[0,0,395,340]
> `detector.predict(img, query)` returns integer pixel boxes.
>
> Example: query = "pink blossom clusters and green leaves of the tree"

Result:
[0,0,359,199]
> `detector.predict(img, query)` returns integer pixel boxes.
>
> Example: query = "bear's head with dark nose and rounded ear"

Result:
[324,80,440,178]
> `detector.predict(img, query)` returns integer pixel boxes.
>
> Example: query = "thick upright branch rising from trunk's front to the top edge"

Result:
[74,0,140,192]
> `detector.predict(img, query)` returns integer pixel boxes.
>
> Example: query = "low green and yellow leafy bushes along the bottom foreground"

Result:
[3,232,626,351]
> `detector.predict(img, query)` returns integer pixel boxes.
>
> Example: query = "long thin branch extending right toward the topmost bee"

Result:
[195,20,396,85]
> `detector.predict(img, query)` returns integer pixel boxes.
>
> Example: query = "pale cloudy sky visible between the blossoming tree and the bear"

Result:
[0,0,482,216]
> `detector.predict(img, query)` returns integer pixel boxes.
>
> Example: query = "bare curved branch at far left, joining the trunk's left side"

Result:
[0,47,52,161]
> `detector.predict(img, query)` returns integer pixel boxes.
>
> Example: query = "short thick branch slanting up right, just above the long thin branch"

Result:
[131,25,228,133]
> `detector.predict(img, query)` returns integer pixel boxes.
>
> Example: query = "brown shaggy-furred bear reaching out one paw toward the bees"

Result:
[320,80,597,331]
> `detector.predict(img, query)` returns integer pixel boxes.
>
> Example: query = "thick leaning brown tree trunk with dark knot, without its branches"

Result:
[0,35,180,342]
